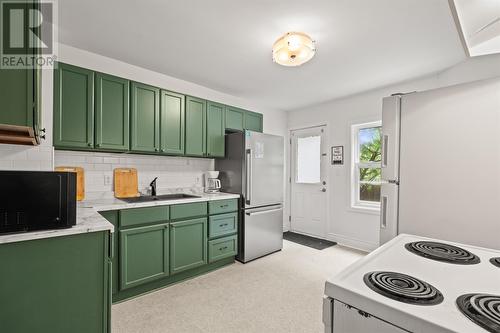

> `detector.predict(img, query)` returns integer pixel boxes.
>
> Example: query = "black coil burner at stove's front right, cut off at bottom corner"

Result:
[457,294,500,333]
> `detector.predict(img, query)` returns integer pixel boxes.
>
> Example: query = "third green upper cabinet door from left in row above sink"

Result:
[130,82,160,152]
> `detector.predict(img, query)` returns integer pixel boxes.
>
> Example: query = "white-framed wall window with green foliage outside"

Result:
[351,121,382,210]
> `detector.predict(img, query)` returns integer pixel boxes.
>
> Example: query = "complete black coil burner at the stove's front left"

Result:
[363,271,443,305]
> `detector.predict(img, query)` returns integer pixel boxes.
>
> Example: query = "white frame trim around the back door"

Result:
[287,122,332,240]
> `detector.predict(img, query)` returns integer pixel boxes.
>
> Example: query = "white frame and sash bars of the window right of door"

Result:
[351,120,382,213]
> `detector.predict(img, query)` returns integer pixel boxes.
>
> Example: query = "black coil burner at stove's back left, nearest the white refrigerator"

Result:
[405,241,481,265]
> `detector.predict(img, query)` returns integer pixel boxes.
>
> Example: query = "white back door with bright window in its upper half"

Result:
[290,126,328,238]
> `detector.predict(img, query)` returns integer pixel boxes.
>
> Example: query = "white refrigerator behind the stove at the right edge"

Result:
[380,78,500,249]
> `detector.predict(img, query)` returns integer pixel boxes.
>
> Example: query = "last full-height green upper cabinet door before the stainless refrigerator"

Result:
[207,102,226,157]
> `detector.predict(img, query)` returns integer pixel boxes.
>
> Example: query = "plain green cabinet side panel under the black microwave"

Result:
[0,231,110,333]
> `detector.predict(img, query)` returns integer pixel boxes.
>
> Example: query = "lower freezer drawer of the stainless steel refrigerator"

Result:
[238,204,283,262]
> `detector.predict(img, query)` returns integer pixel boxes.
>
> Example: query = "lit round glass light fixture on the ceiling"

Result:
[273,32,316,67]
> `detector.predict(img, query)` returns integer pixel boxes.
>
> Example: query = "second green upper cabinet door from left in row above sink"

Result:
[95,73,130,151]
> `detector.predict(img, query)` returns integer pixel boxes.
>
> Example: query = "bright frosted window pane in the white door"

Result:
[296,136,321,184]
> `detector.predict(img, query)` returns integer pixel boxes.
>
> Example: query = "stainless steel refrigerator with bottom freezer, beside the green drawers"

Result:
[215,131,284,262]
